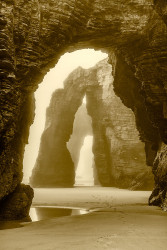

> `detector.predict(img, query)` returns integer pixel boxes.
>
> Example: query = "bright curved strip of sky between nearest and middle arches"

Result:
[23,49,108,183]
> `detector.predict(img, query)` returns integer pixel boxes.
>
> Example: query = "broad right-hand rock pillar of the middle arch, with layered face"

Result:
[86,61,153,190]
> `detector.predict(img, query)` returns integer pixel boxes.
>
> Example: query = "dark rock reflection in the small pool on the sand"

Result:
[35,207,72,220]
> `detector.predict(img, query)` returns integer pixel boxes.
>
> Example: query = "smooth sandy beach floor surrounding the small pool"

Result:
[0,187,167,250]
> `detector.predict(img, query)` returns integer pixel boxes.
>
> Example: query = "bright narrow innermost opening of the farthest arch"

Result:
[75,136,94,186]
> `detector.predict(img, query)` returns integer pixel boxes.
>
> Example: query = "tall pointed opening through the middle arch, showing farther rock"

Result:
[67,95,100,186]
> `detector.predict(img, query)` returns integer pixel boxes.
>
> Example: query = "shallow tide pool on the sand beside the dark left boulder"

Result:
[30,207,88,221]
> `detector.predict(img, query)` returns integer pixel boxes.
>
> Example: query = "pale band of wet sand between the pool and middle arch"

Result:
[32,187,151,208]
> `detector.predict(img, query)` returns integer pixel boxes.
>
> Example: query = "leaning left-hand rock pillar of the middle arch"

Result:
[30,68,85,187]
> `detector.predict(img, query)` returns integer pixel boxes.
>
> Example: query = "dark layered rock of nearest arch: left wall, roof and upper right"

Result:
[0,0,167,216]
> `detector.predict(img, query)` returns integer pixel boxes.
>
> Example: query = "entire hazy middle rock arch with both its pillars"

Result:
[31,59,153,189]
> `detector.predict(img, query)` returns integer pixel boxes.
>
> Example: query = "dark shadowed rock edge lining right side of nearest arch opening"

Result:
[110,53,160,166]
